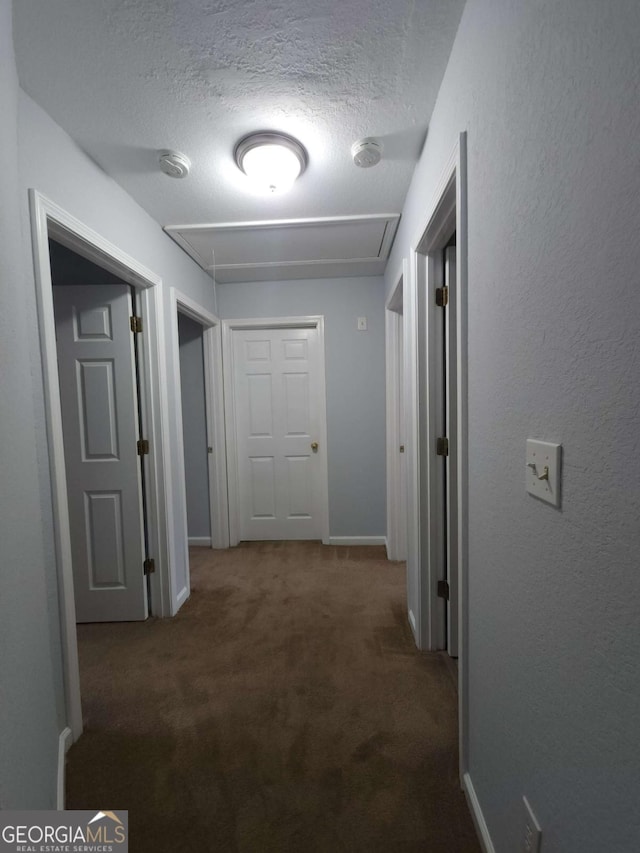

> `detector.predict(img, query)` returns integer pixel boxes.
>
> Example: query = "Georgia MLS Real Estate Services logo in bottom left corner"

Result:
[0,810,129,853]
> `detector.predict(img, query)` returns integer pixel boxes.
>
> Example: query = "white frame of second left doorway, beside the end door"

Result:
[169,287,229,584]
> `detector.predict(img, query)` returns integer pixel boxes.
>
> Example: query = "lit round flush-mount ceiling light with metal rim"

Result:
[235,131,309,192]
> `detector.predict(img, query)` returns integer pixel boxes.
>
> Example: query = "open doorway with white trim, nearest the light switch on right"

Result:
[405,133,468,780]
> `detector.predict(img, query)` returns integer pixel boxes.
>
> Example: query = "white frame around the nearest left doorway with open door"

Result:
[29,189,172,748]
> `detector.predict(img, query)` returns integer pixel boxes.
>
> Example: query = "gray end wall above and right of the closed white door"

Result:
[217,277,386,536]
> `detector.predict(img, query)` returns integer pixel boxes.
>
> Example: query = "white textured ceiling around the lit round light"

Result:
[14,0,464,276]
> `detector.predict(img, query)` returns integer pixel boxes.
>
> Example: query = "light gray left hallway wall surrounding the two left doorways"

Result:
[8,81,214,808]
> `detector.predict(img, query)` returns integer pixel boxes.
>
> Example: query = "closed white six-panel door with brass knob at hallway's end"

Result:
[233,328,326,540]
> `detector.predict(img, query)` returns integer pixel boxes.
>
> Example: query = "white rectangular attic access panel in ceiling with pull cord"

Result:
[164,214,400,283]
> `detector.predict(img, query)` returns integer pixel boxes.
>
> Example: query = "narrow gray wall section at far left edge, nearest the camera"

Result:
[0,0,61,809]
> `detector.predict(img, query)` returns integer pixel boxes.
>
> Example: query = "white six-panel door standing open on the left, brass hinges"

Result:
[53,284,147,622]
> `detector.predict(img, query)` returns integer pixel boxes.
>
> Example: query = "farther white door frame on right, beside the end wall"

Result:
[385,258,409,560]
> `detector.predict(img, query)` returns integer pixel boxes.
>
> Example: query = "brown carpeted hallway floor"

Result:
[67,542,480,853]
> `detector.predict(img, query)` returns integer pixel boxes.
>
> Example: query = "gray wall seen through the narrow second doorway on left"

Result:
[178,314,211,537]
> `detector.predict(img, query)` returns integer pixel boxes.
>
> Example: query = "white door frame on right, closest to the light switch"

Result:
[405,132,469,780]
